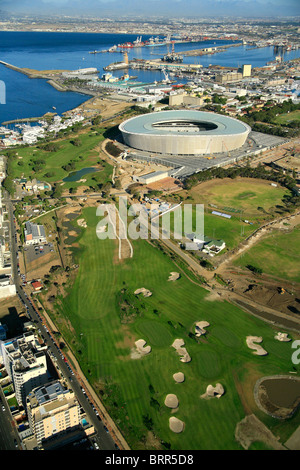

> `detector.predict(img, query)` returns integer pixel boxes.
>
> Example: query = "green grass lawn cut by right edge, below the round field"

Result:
[234,225,300,282]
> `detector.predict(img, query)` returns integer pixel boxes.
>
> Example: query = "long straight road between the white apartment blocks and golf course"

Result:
[4,196,116,450]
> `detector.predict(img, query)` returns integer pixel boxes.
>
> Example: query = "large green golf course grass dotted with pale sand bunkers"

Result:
[45,208,299,450]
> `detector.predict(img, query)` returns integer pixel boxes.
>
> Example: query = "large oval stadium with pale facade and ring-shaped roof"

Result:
[119,110,251,156]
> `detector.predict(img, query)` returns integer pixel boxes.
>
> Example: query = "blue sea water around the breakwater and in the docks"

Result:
[0,31,300,124]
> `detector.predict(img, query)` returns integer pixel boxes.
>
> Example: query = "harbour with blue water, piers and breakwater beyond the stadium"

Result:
[0,32,300,127]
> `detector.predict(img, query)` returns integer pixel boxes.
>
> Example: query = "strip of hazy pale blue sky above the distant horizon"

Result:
[0,0,300,17]
